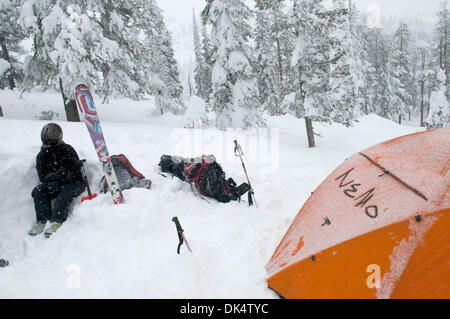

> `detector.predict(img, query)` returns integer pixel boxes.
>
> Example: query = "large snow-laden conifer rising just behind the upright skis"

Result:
[20,0,119,96]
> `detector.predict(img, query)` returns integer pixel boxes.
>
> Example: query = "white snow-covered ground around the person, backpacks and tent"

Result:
[0,90,420,299]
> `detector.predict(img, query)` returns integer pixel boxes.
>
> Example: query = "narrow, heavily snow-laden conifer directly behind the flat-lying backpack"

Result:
[202,0,264,129]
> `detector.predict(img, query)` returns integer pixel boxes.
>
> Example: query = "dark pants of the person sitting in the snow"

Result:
[31,181,86,223]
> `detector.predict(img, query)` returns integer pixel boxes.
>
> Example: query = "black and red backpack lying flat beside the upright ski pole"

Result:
[159,155,250,203]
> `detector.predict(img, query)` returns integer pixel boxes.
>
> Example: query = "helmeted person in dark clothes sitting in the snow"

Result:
[28,123,86,236]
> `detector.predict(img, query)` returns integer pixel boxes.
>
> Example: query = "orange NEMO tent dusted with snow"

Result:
[266,128,450,299]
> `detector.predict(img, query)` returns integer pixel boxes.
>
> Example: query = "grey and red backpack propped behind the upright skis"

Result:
[99,154,152,193]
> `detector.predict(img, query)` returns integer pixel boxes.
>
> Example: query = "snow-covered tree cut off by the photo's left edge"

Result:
[0,0,25,89]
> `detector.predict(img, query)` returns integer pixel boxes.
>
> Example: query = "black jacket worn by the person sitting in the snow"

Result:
[36,142,83,184]
